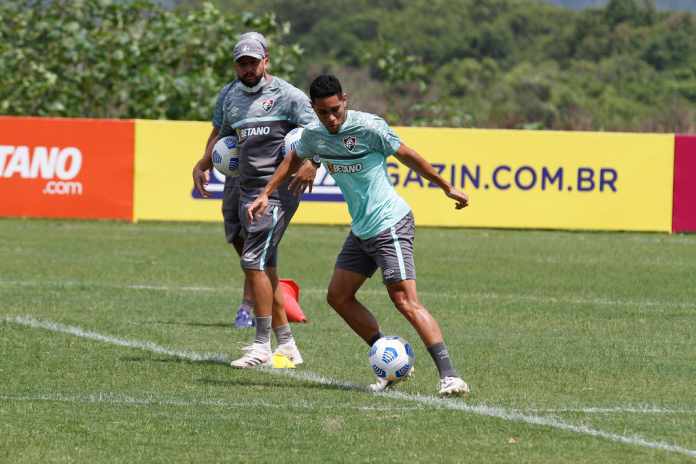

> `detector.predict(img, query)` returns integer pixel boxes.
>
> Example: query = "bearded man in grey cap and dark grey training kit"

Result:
[193,34,318,368]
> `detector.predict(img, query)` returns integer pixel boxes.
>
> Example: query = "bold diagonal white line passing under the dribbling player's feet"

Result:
[0,316,696,458]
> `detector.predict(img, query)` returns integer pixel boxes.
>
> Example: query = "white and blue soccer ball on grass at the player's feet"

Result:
[370,336,416,381]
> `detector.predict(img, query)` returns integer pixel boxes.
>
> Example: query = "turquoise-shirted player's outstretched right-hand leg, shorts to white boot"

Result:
[376,213,469,395]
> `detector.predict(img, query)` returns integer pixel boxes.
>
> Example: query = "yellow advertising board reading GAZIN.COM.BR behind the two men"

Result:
[134,121,674,231]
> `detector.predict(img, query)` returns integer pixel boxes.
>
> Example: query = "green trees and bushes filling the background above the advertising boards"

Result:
[0,0,696,132]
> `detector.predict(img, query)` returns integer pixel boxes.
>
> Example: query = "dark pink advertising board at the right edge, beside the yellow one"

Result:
[672,135,696,232]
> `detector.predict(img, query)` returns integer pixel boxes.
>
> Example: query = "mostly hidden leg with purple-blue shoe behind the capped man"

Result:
[222,177,254,328]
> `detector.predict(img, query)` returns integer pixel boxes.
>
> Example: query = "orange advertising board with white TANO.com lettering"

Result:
[0,116,135,220]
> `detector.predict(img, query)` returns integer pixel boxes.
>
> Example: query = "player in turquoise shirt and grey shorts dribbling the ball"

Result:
[247,75,469,395]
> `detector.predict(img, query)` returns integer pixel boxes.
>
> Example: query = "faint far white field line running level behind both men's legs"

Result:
[0,280,696,310]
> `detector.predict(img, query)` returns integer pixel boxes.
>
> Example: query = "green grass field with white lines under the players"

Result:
[0,220,696,464]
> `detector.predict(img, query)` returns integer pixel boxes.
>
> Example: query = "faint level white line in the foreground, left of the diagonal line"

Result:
[0,392,427,412]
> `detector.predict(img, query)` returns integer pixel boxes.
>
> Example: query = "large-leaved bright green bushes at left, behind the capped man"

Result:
[0,0,301,120]
